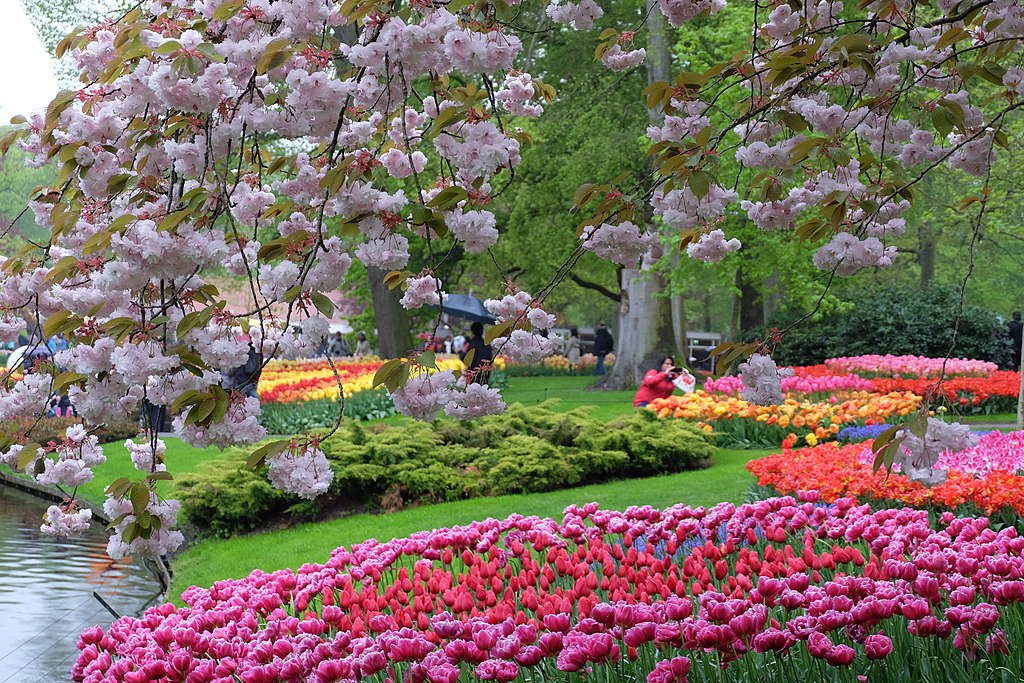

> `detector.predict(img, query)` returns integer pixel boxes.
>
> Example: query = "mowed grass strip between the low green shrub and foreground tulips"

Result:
[168,450,772,604]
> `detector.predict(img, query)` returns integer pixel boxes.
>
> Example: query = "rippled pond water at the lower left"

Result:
[0,485,159,683]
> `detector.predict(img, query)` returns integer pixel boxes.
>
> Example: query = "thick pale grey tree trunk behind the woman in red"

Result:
[603,0,687,389]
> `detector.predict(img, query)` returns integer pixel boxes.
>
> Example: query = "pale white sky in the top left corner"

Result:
[0,0,60,125]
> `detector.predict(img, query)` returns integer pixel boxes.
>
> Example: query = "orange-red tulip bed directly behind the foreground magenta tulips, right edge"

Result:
[746,440,1024,515]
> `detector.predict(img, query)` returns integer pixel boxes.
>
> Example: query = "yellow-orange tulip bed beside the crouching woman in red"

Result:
[647,390,921,446]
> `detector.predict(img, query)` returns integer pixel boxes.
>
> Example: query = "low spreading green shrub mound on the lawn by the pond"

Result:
[174,401,715,536]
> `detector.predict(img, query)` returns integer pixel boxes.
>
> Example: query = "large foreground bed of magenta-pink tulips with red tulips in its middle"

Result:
[74,498,1024,683]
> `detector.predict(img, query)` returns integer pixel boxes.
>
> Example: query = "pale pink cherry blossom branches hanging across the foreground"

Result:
[0,0,1024,556]
